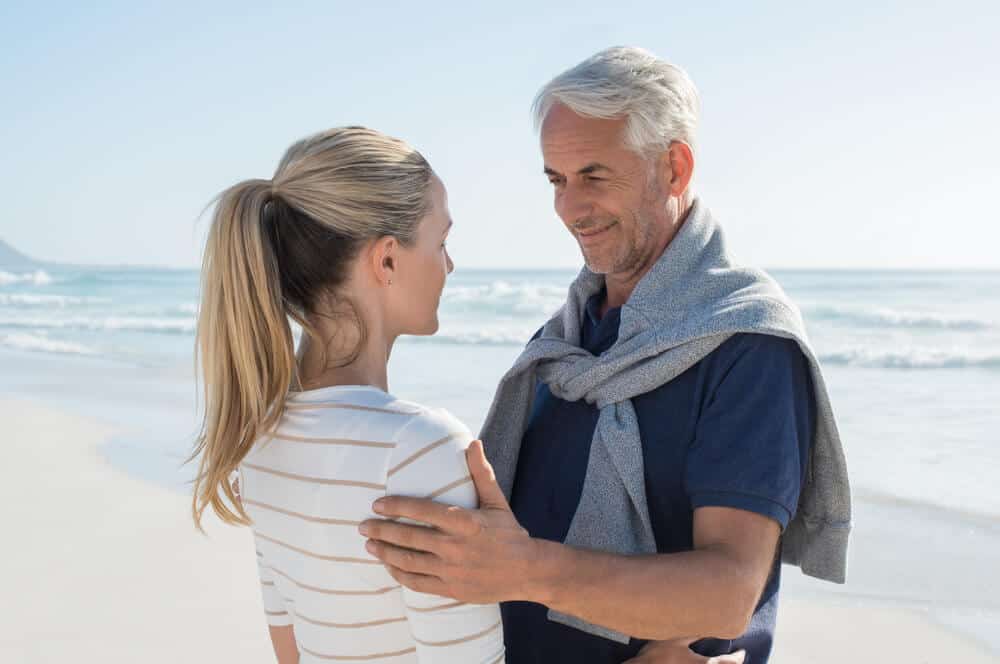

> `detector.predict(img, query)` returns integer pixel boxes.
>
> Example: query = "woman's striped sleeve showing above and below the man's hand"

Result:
[386,411,504,664]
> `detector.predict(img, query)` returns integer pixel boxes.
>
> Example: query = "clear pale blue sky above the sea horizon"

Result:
[0,0,1000,268]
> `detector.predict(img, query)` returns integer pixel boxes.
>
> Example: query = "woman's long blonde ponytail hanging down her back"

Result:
[191,180,295,529]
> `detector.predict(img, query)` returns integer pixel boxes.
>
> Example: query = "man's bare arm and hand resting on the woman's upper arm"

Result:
[362,441,780,640]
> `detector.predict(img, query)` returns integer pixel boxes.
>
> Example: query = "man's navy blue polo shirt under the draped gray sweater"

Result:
[501,292,815,664]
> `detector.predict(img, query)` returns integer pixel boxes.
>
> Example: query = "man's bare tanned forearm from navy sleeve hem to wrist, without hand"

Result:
[540,507,780,640]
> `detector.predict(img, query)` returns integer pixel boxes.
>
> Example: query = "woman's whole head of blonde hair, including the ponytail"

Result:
[188,127,433,529]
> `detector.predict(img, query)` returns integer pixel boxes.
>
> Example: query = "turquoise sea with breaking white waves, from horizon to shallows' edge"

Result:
[0,268,1000,370]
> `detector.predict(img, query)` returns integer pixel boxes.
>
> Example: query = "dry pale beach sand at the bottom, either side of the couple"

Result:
[0,397,1000,664]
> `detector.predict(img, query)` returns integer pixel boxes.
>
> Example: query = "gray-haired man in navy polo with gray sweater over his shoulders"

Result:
[362,48,850,664]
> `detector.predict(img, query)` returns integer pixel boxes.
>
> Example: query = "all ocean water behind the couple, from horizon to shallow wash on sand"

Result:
[0,267,1000,517]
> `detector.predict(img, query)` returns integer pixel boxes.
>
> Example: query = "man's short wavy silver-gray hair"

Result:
[532,46,701,155]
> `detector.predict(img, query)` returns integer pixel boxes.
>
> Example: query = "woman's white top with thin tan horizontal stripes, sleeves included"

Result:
[240,386,504,664]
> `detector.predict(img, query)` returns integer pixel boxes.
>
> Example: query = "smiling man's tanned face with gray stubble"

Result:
[541,104,672,276]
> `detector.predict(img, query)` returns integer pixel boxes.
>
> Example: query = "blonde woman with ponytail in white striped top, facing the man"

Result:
[192,127,504,664]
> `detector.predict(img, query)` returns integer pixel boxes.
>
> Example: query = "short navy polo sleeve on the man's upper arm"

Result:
[685,334,815,530]
